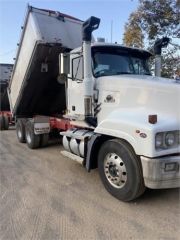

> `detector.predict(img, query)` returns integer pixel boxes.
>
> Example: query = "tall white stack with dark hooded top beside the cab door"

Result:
[83,17,100,127]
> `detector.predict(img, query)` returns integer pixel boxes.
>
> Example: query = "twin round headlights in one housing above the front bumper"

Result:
[155,131,180,150]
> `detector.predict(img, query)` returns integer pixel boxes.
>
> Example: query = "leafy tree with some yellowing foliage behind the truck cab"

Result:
[124,0,180,77]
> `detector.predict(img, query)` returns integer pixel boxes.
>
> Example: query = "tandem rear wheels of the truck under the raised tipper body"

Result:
[16,119,49,149]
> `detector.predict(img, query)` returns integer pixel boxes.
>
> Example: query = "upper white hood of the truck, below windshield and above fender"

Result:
[96,75,180,125]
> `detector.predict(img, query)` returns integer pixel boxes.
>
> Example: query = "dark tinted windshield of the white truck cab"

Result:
[92,47,151,77]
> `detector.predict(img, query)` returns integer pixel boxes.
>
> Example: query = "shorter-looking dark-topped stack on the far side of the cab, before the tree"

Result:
[154,37,170,77]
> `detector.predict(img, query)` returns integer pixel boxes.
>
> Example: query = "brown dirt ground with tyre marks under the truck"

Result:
[0,126,180,240]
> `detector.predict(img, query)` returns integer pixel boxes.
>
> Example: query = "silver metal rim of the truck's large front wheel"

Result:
[104,153,127,188]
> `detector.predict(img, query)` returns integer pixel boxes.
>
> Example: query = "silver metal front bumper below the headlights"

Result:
[141,155,180,189]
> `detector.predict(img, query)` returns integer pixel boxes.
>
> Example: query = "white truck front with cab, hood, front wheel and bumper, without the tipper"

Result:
[60,20,180,201]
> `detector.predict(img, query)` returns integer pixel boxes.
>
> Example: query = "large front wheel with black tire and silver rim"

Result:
[98,139,145,202]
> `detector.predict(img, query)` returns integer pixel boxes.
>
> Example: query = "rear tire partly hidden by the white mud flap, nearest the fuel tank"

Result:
[25,121,40,149]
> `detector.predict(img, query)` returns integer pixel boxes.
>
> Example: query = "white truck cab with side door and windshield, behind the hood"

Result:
[68,43,151,119]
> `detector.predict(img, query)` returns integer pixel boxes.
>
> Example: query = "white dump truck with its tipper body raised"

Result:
[9,7,180,201]
